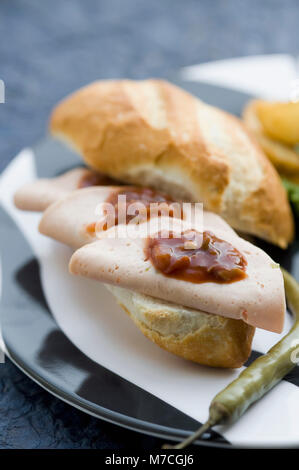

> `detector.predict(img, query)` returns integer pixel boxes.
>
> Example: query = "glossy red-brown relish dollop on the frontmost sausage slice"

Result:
[145,230,247,284]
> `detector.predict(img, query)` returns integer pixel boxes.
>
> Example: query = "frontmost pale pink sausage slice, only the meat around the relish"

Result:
[70,218,286,333]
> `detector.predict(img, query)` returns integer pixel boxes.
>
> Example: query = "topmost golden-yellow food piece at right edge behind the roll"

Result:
[256,101,299,145]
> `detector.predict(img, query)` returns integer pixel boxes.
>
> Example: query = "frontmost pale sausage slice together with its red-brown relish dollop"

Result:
[70,213,285,332]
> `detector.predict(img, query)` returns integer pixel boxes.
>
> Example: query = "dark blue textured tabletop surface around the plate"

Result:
[0,0,299,449]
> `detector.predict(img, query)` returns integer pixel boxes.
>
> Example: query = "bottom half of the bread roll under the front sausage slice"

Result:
[107,285,255,367]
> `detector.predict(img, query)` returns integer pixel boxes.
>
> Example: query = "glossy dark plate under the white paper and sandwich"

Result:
[0,82,299,446]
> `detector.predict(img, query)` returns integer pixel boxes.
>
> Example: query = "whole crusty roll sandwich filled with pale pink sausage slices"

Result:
[15,80,293,367]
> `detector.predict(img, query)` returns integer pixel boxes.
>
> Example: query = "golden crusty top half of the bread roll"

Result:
[50,80,294,248]
